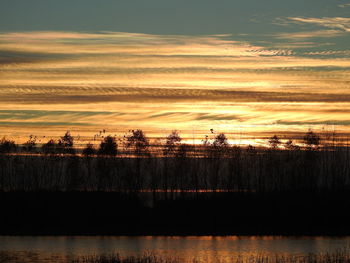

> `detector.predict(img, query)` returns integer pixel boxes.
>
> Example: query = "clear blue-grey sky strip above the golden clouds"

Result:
[0,0,350,35]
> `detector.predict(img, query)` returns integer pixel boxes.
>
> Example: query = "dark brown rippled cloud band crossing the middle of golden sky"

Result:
[0,87,350,105]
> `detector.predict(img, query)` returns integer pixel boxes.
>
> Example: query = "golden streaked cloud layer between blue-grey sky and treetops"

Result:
[0,31,350,145]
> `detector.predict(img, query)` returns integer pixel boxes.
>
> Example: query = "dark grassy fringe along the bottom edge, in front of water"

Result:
[0,249,350,263]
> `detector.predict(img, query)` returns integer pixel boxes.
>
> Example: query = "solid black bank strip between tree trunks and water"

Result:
[0,192,350,235]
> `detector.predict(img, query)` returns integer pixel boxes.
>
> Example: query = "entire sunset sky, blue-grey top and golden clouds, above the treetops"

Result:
[0,0,350,144]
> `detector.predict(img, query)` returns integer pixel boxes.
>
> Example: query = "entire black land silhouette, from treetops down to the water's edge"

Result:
[0,130,350,235]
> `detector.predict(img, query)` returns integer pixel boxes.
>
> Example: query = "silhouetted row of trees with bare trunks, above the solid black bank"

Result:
[0,130,350,195]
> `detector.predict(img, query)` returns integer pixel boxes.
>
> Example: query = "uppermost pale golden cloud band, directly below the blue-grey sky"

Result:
[0,32,290,56]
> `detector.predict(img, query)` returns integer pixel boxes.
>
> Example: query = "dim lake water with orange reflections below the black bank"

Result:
[0,236,350,263]
